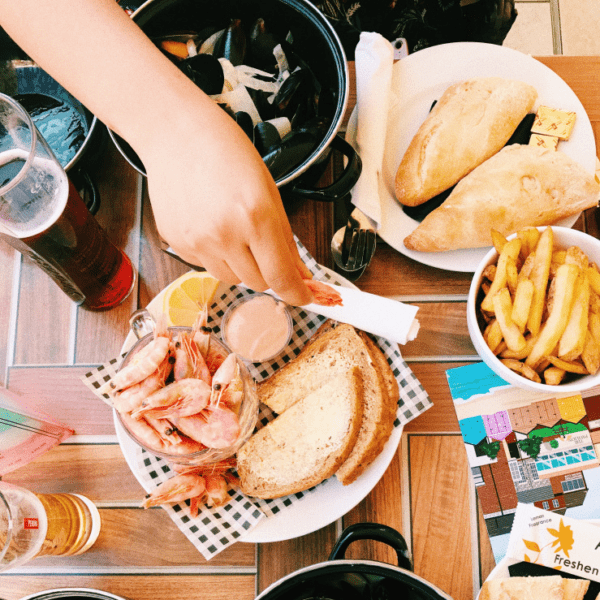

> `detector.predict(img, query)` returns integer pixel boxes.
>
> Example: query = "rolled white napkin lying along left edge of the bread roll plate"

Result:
[352,31,394,229]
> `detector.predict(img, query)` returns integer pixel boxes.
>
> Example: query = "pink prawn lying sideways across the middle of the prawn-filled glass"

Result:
[132,379,211,419]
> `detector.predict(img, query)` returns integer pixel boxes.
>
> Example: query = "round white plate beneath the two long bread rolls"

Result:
[346,42,596,273]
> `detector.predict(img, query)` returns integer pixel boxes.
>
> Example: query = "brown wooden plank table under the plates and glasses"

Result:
[0,56,600,600]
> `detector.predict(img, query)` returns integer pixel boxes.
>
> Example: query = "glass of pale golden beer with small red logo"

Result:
[0,481,100,572]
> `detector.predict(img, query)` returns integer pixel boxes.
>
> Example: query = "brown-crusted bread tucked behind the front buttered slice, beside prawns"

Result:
[258,321,400,485]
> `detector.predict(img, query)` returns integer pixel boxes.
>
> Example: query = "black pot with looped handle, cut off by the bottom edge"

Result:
[256,523,452,600]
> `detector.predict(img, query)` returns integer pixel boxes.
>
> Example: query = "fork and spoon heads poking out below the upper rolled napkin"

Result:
[331,208,377,275]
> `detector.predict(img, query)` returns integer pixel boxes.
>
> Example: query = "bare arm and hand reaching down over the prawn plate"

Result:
[0,0,311,305]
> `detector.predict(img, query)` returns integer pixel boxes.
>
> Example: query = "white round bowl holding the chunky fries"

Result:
[467,226,600,393]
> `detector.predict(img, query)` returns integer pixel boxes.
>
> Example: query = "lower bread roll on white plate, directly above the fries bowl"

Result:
[404,144,600,252]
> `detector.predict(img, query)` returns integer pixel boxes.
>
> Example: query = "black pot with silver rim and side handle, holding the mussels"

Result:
[110,0,361,201]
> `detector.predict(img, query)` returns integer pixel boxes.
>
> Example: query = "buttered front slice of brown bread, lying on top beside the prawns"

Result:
[237,367,363,498]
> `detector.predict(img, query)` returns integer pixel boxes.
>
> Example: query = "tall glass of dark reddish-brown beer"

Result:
[0,94,136,310]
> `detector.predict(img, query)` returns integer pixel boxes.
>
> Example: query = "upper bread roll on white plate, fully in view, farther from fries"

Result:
[396,77,537,206]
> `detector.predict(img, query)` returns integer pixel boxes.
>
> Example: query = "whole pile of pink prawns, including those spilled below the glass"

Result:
[100,307,244,506]
